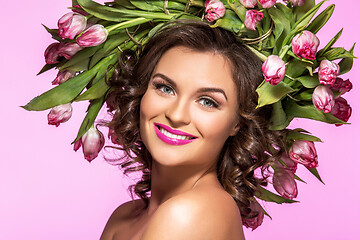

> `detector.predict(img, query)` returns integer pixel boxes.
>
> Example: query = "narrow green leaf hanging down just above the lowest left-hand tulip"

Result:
[71,98,105,144]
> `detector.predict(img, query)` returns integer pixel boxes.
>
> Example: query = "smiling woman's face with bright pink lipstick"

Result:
[140,46,238,166]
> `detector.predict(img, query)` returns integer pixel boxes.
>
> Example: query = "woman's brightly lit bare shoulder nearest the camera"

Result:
[142,188,244,240]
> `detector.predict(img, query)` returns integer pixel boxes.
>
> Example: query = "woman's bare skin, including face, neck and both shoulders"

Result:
[101,46,244,240]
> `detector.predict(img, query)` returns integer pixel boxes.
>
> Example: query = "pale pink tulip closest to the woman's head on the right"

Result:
[262,55,286,85]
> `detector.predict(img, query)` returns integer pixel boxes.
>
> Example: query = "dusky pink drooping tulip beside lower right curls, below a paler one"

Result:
[273,169,298,199]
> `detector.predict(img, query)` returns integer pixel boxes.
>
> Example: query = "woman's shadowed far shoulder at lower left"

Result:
[100,199,144,240]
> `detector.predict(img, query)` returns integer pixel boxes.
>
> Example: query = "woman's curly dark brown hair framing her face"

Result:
[108,21,284,217]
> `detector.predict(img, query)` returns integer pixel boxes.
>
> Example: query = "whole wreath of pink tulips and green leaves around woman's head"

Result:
[24,0,354,229]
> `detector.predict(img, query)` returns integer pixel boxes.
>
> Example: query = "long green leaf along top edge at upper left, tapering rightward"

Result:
[78,0,175,22]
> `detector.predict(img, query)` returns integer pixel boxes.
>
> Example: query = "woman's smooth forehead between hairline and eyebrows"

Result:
[153,46,236,91]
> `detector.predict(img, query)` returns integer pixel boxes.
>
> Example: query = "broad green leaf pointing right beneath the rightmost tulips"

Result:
[283,99,347,124]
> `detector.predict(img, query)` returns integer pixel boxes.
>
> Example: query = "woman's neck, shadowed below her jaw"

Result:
[148,161,220,214]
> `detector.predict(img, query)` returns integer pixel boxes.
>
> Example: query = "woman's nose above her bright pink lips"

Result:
[165,99,191,127]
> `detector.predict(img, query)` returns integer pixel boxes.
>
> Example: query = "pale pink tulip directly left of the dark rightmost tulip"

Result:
[312,85,335,113]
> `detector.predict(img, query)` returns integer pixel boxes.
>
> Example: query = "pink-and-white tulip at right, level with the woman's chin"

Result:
[289,140,319,168]
